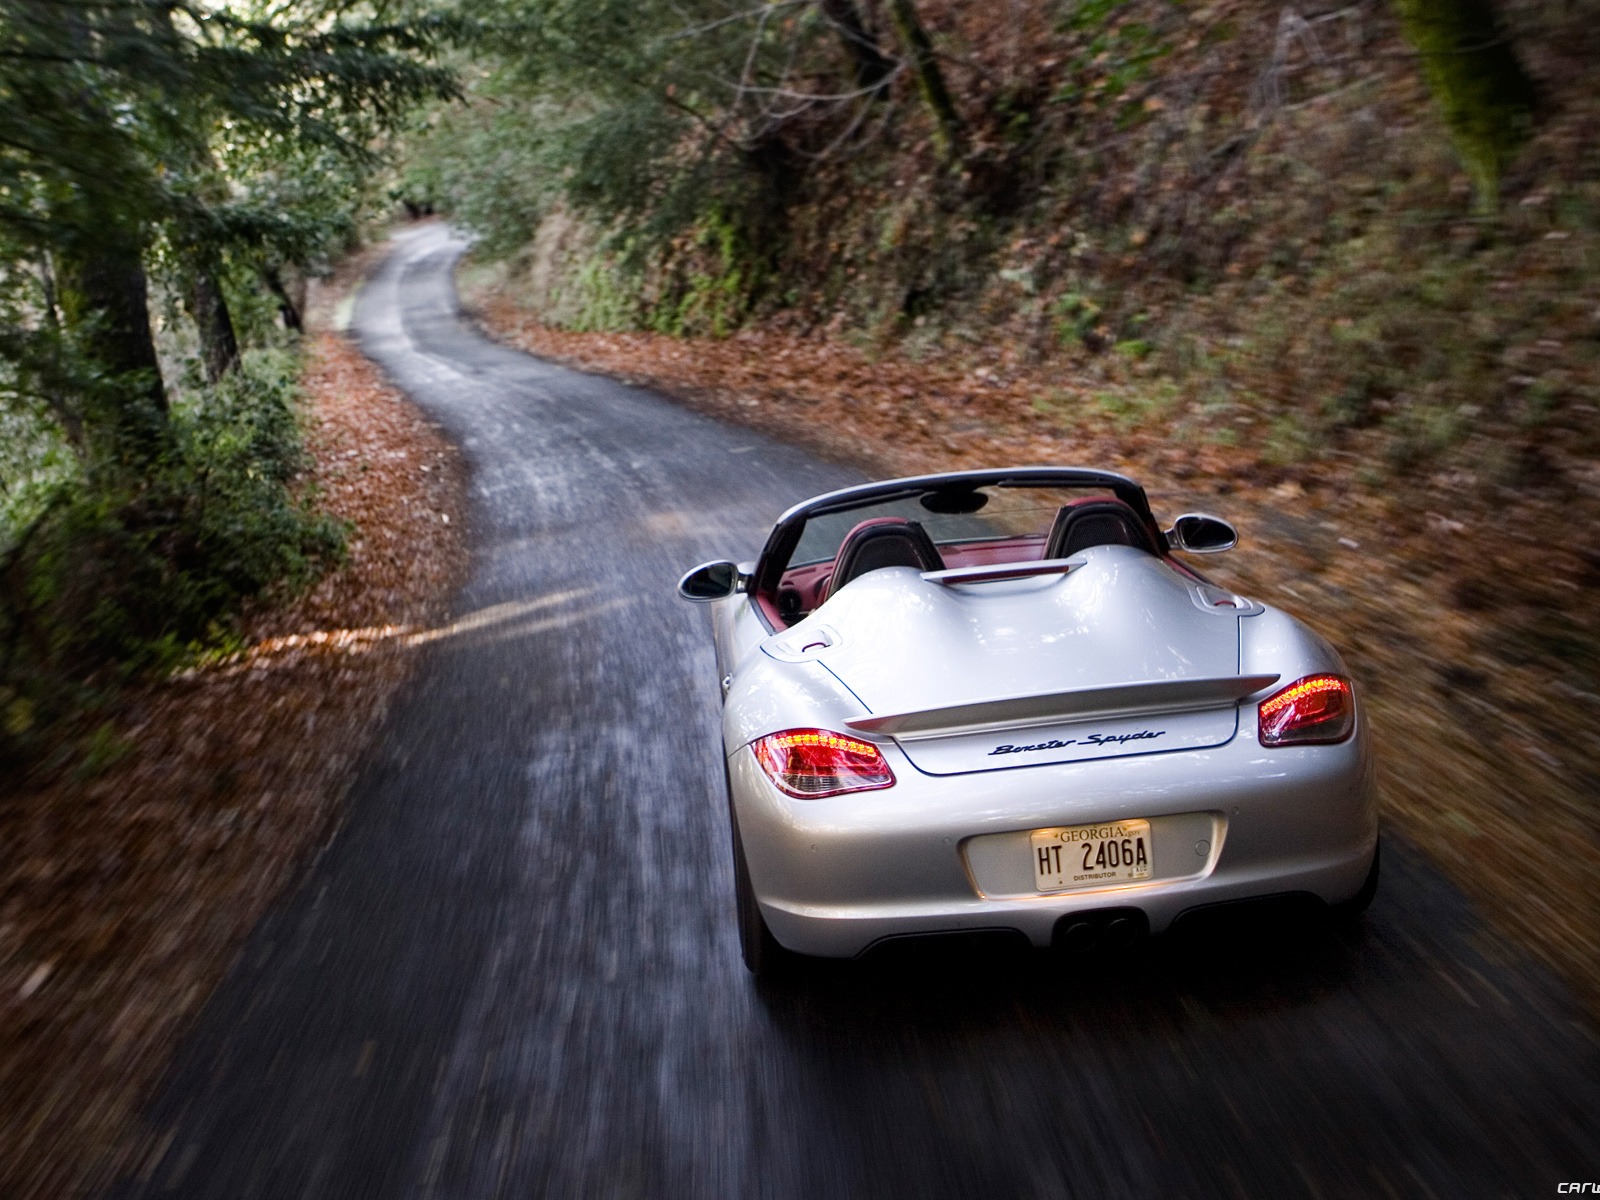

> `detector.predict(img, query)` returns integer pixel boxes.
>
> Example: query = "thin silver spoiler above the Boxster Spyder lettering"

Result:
[845,675,1280,741]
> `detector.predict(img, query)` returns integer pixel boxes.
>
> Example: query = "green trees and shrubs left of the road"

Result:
[0,0,454,778]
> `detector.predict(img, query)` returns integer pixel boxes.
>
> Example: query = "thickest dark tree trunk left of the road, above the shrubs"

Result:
[56,230,168,466]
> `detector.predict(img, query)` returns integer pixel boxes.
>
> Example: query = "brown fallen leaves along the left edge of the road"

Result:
[0,296,466,1200]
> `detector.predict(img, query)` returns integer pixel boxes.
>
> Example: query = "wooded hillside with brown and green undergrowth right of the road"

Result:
[396,0,1600,494]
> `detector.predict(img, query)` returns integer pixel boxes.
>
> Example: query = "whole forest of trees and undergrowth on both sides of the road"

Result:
[0,0,1600,755]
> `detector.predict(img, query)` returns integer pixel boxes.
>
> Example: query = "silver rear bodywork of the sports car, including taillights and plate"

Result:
[728,552,1378,957]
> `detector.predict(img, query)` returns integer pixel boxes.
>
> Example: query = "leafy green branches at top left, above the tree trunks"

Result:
[0,0,454,262]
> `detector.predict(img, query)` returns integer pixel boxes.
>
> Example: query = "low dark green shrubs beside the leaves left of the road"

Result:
[0,352,344,755]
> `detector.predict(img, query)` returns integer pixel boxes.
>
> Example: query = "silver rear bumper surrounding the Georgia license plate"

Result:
[728,730,1378,957]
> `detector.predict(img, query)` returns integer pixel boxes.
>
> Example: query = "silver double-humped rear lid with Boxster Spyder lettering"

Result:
[786,546,1275,774]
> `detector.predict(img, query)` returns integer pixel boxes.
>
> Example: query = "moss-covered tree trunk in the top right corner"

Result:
[1395,0,1538,213]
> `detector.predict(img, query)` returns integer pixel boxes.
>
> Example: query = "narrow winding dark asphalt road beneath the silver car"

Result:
[115,226,1600,1200]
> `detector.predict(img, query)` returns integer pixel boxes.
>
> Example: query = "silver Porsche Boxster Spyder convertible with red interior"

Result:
[678,467,1378,974]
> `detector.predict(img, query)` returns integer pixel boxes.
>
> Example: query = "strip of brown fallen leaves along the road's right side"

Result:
[470,285,1600,1013]
